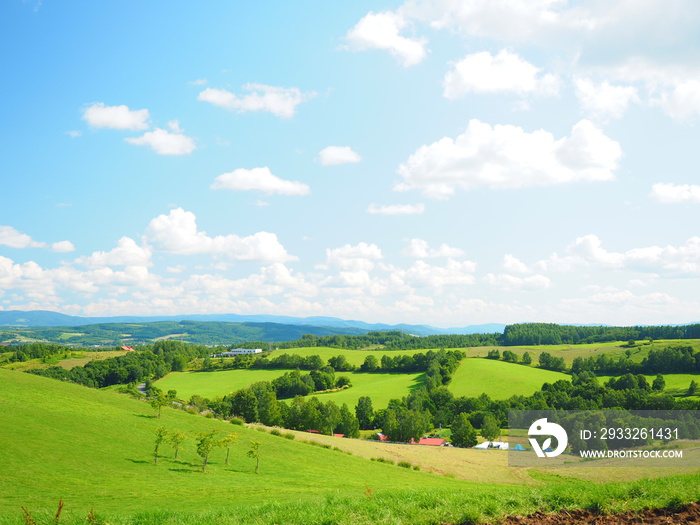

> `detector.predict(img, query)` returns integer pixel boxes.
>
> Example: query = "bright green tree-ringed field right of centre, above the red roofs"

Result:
[449,358,571,399]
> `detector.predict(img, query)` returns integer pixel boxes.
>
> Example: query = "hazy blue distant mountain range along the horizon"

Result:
[0,310,506,335]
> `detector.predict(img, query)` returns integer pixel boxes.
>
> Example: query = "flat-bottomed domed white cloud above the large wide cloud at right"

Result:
[443,49,559,99]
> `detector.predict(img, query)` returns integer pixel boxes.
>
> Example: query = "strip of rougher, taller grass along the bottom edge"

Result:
[8,475,700,525]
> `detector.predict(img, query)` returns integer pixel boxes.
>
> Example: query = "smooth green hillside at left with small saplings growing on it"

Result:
[0,370,470,516]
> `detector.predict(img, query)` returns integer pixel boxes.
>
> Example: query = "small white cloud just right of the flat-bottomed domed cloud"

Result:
[574,78,640,119]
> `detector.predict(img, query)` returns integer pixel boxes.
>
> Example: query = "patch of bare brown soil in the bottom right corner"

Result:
[499,503,700,525]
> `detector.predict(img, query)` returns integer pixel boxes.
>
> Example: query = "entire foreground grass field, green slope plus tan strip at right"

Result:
[0,370,700,525]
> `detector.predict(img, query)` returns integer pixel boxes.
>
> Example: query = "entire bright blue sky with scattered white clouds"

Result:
[0,0,700,326]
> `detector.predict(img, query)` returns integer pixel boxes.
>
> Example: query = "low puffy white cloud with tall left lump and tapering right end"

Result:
[146,208,296,262]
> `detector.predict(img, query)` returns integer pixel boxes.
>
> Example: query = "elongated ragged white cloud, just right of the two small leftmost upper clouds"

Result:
[197,83,316,118]
